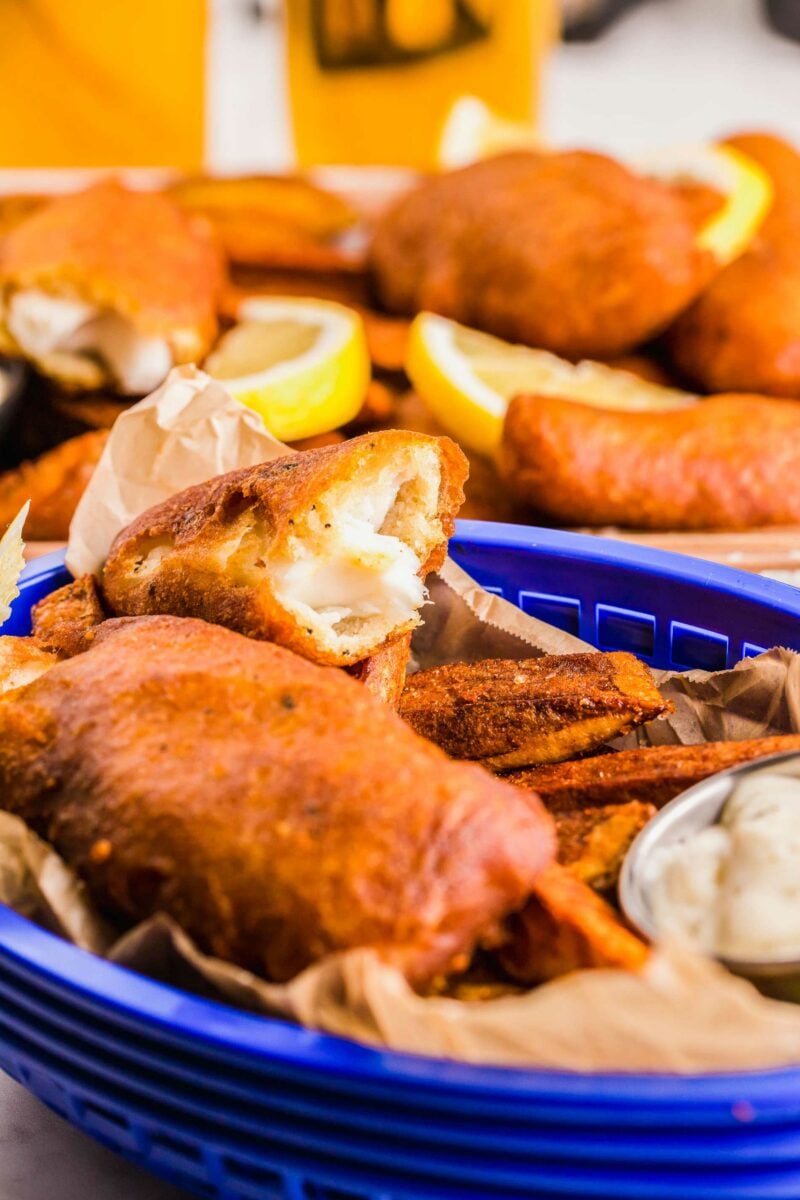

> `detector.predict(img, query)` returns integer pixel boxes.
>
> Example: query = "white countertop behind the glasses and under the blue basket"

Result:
[6,0,800,1200]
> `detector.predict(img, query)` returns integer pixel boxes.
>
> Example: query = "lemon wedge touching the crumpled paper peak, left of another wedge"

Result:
[205,296,369,442]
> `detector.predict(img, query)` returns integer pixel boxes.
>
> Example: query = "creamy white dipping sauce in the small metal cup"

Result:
[649,772,800,962]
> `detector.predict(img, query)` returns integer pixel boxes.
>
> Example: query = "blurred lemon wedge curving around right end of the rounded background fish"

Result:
[636,145,774,264]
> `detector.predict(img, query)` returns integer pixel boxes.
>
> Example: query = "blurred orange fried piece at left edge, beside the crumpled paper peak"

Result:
[0,430,108,541]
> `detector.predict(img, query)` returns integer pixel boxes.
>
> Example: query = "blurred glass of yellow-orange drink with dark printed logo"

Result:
[287,0,557,169]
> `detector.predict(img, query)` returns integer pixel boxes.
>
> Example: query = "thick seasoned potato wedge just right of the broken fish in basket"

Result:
[399,652,670,770]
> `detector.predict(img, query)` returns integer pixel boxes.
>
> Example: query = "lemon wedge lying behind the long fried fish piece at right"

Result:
[405,312,697,456]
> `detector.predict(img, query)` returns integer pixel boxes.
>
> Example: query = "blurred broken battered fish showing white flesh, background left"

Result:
[0,182,223,395]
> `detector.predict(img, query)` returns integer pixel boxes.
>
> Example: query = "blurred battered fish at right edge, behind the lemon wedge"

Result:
[668,133,800,397]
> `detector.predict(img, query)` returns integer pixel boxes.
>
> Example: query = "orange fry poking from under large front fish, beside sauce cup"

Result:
[499,863,648,984]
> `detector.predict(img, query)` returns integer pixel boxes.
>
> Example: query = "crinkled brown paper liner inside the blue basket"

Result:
[7,367,800,1073]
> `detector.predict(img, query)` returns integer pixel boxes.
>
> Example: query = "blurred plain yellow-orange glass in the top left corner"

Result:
[0,0,206,168]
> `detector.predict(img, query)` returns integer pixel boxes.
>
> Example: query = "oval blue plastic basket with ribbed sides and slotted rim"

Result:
[0,522,800,1200]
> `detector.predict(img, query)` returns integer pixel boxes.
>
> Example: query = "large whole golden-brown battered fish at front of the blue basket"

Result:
[0,617,554,988]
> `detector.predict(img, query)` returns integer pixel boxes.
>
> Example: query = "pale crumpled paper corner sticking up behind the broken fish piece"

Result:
[66,366,295,576]
